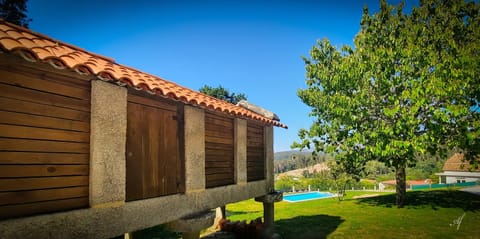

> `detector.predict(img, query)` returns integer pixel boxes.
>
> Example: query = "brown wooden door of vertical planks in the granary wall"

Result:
[126,89,185,201]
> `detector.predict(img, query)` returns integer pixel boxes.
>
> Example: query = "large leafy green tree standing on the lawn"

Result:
[292,0,480,207]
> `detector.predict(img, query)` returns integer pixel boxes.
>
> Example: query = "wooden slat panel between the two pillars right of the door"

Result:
[205,112,235,188]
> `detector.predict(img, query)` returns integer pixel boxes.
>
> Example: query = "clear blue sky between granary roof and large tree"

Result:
[28,0,409,152]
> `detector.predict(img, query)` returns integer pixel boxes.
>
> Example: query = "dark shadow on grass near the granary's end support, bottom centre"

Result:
[275,215,345,239]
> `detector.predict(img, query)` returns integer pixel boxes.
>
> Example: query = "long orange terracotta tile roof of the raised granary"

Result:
[0,19,287,128]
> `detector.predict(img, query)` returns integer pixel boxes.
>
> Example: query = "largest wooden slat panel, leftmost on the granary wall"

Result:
[0,68,90,219]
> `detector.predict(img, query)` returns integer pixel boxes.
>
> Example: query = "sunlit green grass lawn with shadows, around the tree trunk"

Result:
[227,190,480,239]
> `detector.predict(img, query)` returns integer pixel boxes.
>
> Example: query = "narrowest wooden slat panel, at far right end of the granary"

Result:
[247,121,265,182]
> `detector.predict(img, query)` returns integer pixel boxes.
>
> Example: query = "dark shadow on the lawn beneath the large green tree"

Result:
[357,190,480,211]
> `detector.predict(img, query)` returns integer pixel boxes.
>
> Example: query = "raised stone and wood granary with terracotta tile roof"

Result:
[0,20,287,238]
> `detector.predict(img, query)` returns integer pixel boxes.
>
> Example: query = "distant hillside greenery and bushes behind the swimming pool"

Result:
[274,151,445,194]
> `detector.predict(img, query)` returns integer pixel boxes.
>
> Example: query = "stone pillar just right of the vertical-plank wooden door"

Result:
[184,106,205,193]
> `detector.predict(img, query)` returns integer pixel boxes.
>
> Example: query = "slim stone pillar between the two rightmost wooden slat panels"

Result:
[234,118,247,184]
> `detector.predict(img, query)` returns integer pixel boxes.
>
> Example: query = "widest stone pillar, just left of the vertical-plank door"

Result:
[89,80,127,207]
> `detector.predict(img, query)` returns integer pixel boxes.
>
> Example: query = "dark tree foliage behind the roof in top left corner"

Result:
[0,0,32,28]
